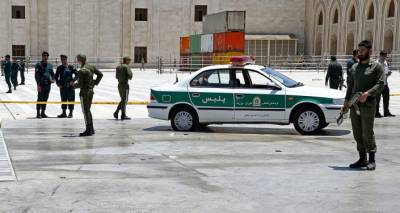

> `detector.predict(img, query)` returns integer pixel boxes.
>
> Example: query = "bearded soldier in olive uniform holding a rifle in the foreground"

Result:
[342,41,384,170]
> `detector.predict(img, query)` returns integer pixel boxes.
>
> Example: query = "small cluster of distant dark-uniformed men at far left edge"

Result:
[1,55,25,93]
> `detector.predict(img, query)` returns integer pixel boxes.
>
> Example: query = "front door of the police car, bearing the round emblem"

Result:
[234,69,286,123]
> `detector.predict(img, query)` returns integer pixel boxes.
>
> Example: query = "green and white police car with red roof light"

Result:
[147,56,345,135]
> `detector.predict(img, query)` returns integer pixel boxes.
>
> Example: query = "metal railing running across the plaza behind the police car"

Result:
[10,54,400,73]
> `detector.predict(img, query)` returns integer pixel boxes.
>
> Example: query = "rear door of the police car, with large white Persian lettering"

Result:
[189,69,235,123]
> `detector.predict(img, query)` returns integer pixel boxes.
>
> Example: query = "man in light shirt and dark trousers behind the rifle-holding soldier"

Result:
[375,50,395,118]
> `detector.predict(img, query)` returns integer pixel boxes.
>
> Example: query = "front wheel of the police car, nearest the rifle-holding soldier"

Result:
[293,107,329,135]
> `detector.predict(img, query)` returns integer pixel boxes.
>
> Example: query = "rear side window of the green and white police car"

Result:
[190,70,231,88]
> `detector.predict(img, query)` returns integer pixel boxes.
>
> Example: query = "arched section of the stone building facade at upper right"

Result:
[305,0,400,55]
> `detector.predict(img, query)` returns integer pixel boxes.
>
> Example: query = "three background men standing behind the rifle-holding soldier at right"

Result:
[325,47,395,118]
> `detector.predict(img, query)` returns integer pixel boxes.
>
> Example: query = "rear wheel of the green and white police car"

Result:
[171,107,199,132]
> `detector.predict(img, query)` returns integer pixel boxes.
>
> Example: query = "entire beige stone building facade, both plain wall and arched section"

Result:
[0,0,400,62]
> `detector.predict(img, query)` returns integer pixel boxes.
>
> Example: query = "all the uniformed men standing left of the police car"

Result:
[4,52,132,137]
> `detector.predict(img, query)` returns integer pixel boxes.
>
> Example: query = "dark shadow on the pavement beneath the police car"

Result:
[143,126,351,136]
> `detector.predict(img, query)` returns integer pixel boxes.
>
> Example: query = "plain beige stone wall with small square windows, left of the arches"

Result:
[0,0,305,61]
